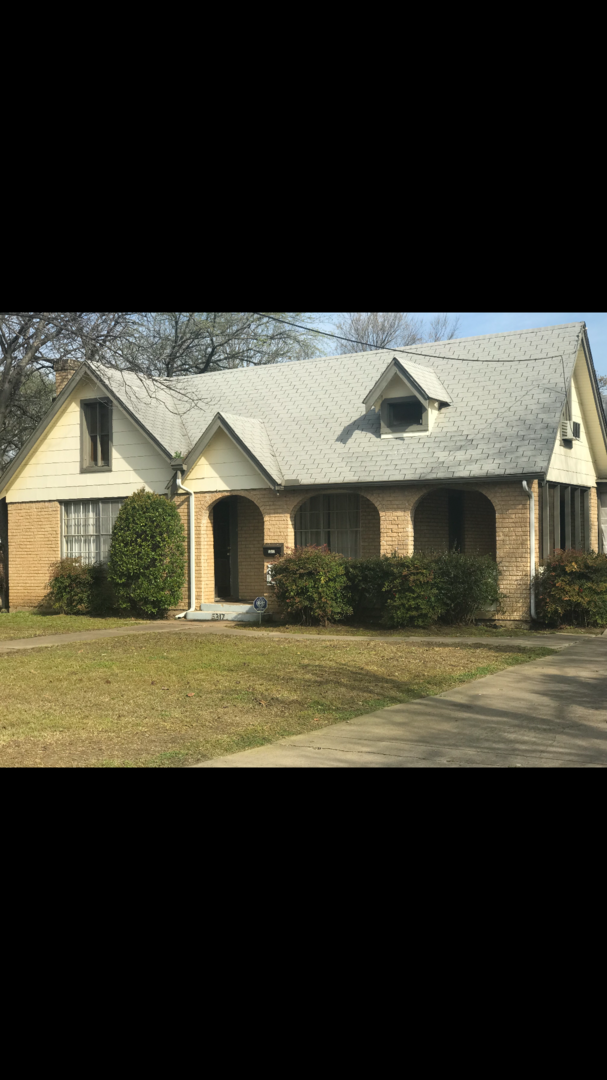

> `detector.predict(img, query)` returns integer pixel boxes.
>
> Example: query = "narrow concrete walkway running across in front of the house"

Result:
[0,619,580,652]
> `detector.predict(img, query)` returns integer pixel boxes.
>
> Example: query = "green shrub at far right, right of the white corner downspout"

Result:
[536,550,607,626]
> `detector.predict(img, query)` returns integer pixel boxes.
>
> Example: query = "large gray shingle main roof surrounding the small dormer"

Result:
[92,323,583,484]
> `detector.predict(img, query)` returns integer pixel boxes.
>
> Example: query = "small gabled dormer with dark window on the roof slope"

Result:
[364,356,453,438]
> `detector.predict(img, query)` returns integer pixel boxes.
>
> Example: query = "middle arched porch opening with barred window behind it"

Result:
[294,491,379,558]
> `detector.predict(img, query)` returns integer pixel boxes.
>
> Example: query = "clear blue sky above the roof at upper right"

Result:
[315,311,607,375]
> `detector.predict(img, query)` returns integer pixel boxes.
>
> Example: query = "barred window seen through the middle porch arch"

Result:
[295,495,361,558]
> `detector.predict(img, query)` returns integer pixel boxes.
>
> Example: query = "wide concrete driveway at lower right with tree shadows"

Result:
[195,636,607,769]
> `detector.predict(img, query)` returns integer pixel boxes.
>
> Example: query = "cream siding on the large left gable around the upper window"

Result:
[2,381,172,502]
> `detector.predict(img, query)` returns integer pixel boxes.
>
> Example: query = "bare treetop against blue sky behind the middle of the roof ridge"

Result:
[336,311,459,352]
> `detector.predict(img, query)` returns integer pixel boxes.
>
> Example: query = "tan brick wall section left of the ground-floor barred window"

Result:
[9,502,60,611]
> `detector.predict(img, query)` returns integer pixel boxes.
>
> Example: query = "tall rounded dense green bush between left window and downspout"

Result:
[108,488,186,618]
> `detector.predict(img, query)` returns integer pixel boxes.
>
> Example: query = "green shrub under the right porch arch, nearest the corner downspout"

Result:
[433,551,501,623]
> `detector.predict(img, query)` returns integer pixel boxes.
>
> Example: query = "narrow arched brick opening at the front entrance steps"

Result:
[210,495,265,603]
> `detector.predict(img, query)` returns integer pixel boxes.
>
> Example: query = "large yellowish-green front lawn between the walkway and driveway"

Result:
[0,634,549,767]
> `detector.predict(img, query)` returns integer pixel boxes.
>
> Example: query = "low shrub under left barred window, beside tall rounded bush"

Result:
[40,556,113,615]
